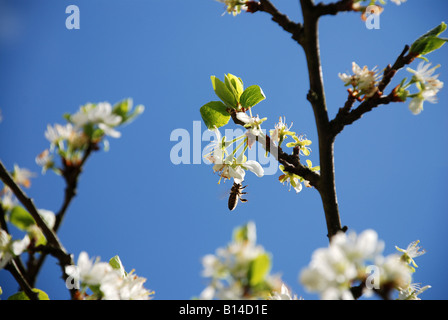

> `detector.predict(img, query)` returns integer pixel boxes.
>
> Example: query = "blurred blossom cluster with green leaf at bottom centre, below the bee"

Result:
[199,222,297,300]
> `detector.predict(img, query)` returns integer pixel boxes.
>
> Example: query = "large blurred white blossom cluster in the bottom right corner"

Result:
[300,230,430,300]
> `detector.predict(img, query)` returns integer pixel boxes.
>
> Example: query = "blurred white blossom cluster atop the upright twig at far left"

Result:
[36,99,144,174]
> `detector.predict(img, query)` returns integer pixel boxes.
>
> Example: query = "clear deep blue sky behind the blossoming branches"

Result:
[0,0,448,299]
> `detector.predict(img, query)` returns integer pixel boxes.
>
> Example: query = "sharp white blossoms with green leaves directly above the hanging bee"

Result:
[200,74,320,198]
